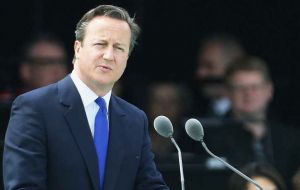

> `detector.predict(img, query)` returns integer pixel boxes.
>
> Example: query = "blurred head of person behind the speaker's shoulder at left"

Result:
[17,34,68,94]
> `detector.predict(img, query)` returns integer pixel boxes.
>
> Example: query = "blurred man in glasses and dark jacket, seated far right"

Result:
[206,56,300,188]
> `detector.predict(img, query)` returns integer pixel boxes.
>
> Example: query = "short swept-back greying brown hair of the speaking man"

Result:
[75,5,140,53]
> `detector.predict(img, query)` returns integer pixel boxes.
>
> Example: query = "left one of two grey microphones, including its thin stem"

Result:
[154,115,185,190]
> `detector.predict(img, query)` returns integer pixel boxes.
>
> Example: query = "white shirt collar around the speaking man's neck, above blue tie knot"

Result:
[71,70,111,110]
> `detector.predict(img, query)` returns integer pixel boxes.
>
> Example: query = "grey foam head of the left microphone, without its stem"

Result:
[154,115,173,138]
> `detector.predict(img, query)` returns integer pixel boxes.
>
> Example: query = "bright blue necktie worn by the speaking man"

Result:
[94,97,108,190]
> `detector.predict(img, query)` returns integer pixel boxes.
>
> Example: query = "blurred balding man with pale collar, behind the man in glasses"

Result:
[195,34,244,117]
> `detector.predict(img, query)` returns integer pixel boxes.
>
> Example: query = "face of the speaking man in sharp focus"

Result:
[74,16,131,95]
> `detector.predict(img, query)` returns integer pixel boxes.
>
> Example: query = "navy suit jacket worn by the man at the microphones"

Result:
[3,76,168,190]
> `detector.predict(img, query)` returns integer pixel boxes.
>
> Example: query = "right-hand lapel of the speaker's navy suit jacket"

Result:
[104,95,127,190]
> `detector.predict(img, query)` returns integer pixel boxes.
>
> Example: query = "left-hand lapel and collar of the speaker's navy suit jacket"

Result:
[58,76,100,190]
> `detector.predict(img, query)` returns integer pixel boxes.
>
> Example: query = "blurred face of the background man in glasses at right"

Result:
[229,71,273,116]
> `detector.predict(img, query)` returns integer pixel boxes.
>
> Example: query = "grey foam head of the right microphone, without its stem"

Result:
[185,118,204,141]
